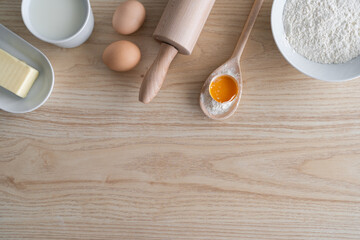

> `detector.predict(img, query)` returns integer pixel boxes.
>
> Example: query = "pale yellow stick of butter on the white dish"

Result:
[0,49,39,98]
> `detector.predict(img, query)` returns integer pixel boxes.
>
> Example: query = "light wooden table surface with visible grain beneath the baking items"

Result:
[0,0,360,240]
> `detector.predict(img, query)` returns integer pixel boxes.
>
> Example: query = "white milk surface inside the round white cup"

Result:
[29,0,87,40]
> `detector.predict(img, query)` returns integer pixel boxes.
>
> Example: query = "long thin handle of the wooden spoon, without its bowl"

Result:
[231,0,264,62]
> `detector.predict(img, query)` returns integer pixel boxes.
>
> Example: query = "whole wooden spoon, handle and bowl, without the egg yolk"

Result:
[200,0,264,120]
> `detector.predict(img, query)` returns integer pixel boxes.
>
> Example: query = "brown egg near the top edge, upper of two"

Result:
[112,0,146,35]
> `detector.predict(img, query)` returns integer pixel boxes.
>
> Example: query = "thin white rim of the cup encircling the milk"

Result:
[21,0,91,45]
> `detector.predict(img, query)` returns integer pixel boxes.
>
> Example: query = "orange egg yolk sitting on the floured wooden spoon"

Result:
[209,75,238,103]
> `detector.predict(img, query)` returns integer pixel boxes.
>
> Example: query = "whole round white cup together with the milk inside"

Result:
[21,0,94,48]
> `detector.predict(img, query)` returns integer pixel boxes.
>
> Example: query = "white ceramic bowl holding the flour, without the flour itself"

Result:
[271,0,360,82]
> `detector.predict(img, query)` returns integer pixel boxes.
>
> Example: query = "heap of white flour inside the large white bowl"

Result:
[283,0,360,64]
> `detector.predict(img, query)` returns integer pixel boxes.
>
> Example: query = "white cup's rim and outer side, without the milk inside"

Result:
[21,0,94,48]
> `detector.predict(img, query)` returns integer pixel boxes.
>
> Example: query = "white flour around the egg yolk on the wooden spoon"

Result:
[200,66,241,116]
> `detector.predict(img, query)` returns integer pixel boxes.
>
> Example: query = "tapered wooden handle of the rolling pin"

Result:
[139,43,178,103]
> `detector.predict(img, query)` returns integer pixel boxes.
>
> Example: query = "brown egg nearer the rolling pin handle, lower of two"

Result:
[102,41,141,72]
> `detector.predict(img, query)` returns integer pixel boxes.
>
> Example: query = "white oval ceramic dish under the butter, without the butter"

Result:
[0,24,54,113]
